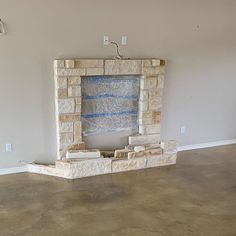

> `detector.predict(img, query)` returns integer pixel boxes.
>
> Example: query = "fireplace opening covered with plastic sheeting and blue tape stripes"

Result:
[81,75,141,150]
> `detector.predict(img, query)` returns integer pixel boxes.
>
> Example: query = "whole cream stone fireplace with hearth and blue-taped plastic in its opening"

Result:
[29,59,177,179]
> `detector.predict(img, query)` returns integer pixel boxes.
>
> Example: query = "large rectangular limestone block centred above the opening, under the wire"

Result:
[105,60,142,75]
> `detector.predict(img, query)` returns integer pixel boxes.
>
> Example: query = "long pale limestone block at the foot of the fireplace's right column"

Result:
[129,134,160,146]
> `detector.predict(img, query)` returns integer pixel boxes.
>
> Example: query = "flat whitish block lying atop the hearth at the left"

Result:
[66,150,101,159]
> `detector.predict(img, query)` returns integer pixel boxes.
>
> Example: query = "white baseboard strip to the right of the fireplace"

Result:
[178,139,236,152]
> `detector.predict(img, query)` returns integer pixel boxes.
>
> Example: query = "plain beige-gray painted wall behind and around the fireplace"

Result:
[0,0,236,168]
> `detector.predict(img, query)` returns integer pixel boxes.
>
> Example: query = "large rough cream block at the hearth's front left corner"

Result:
[70,158,112,179]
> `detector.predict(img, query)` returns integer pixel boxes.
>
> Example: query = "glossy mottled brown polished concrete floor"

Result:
[0,145,236,236]
